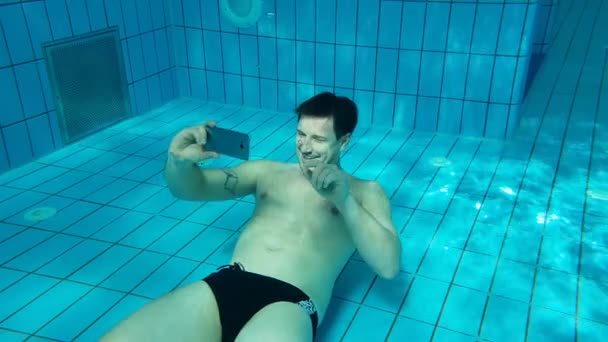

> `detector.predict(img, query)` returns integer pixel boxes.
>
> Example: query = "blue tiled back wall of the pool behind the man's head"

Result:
[171,0,553,138]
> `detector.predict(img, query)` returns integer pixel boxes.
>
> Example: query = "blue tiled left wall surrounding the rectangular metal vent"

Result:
[0,0,177,172]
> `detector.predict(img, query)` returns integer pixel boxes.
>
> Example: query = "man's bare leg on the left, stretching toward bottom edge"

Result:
[101,281,221,342]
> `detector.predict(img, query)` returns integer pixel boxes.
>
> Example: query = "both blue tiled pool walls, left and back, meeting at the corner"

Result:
[0,0,552,172]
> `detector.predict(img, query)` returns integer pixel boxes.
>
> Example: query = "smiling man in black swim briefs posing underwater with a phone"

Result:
[104,93,401,342]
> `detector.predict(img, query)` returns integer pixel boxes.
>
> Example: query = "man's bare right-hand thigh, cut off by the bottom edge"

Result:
[236,302,312,342]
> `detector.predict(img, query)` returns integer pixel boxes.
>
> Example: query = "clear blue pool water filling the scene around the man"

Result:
[0,0,608,342]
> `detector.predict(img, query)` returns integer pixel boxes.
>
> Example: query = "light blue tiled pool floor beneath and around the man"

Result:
[0,99,608,341]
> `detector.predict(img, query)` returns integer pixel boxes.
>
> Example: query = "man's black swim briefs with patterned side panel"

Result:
[203,263,318,342]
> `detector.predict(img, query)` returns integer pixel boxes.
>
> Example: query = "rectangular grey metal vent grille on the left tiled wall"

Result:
[43,27,131,144]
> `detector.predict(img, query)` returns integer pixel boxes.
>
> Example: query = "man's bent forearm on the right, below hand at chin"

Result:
[338,195,401,279]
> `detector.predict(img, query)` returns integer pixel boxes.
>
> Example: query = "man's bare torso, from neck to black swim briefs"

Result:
[232,164,363,319]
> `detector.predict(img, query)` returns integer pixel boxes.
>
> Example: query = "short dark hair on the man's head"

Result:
[296,92,359,139]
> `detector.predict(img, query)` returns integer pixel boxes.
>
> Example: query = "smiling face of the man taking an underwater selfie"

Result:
[296,115,348,175]
